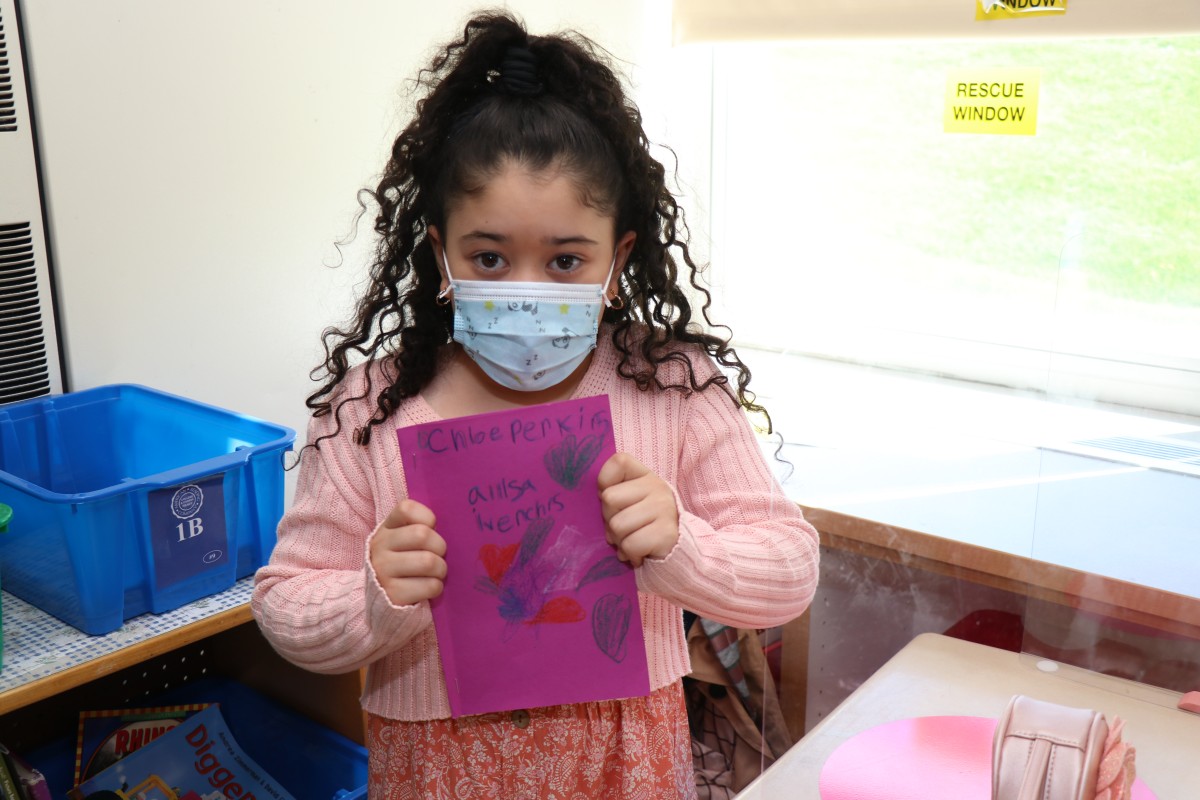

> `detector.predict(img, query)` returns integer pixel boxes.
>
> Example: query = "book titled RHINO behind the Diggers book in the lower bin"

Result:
[74,703,208,784]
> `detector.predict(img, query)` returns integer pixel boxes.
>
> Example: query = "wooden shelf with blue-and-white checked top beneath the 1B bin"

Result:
[0,578,365,751]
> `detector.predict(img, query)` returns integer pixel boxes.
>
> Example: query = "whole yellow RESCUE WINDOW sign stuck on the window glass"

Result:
[944,68,1042,136]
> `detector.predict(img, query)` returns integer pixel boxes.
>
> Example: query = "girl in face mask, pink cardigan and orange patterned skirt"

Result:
[253,9,817,799]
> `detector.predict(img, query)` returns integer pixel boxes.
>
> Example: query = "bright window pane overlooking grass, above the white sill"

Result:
[674,0,1200,414]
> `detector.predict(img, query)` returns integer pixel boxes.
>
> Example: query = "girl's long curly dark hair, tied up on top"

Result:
[306,11,770,444]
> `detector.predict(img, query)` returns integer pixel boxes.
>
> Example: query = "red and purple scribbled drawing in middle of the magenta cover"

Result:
[475,517,629,642]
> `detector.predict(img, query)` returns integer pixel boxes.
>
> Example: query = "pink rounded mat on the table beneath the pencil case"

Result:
[820,717,1157,800]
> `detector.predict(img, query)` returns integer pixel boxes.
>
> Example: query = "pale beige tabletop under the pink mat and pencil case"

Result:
[738,633,1200,800]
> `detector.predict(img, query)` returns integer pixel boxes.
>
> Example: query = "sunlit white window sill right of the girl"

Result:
[742,350,1200,596]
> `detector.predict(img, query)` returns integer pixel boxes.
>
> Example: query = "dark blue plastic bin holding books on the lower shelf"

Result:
[26,678,367,800]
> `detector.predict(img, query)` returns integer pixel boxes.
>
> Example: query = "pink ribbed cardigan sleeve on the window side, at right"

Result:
[638,367,820,627]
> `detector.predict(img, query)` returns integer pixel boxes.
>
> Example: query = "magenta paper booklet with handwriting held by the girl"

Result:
[396,396,649,717]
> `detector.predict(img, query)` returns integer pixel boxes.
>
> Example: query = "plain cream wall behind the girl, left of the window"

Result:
[23,0,691,494]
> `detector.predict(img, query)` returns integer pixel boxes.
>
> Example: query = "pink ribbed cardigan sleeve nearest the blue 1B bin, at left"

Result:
[251,407,432,673]
